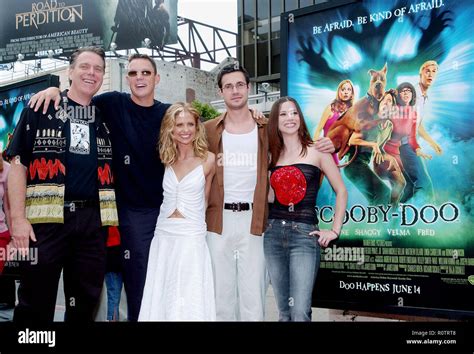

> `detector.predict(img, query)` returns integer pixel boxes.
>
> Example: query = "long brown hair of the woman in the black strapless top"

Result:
[268,96,313,168]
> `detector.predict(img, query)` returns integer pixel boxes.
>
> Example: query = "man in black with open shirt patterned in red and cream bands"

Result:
[7,47,118,325]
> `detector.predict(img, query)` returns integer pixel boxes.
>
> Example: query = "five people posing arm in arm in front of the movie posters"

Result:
[1,47,347,325]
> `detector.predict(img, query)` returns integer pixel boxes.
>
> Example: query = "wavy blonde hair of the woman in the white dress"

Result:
[158,102,208,166]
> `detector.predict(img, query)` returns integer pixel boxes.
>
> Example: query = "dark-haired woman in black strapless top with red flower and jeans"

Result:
[264,97,347,321]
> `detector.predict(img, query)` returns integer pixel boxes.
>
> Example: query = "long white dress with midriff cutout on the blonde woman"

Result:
[138,165,216,321]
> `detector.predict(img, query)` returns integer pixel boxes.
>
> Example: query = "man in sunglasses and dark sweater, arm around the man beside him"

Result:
[30,54,169,321]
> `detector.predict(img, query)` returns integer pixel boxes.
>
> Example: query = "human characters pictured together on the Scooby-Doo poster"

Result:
[314,60,442,205]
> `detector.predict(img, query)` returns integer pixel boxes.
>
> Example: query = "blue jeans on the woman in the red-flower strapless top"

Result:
[263,219,321,321]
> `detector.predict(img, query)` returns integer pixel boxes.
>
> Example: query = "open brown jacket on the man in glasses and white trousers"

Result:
[204,113,268,236]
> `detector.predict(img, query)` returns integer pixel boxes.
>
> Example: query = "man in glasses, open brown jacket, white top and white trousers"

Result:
[205,64,334,321]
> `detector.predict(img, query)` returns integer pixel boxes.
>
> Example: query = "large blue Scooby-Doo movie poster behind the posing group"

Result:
[282,0,474,318]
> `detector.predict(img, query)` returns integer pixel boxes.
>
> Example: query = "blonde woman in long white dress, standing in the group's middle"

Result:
[138,103,216,321]
